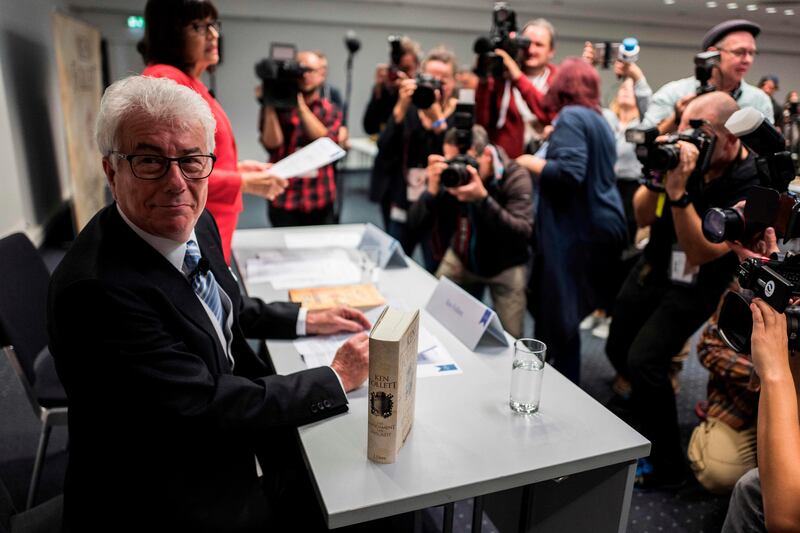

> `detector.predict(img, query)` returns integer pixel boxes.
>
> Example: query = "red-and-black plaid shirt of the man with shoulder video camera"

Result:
[270,98,342,213]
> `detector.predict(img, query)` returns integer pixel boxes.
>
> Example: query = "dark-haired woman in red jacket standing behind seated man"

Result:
[137,0,286,263]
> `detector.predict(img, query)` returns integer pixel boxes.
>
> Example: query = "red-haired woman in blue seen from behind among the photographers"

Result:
[517,58,627,383]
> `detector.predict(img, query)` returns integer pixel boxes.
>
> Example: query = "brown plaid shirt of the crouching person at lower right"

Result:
[697,304,759,430]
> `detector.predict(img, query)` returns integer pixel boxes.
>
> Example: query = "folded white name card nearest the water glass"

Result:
[425,277,508,350]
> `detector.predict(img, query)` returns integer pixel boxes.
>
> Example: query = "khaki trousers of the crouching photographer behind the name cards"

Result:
[436,248,528,339]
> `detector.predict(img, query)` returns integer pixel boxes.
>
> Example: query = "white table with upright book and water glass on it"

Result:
[233,225,650,532]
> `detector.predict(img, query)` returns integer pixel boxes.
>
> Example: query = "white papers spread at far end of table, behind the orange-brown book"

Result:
[245,250,361,289]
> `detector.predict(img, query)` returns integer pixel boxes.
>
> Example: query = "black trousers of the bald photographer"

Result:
[606,258,724,469]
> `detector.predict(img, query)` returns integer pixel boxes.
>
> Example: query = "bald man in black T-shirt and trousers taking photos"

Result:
[606,92,758,489]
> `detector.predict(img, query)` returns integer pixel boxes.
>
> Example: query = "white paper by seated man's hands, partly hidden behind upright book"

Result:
[294,326,462,378]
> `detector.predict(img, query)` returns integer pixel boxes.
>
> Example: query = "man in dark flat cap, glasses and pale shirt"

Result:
[642,19,774,133]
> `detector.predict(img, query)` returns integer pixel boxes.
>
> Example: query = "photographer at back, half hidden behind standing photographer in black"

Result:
[363,36,422,135]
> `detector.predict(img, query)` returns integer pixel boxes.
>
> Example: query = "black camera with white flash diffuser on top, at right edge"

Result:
[703,108,800,243]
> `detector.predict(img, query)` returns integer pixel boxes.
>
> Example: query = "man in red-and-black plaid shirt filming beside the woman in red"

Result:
[261,51,342,227]
